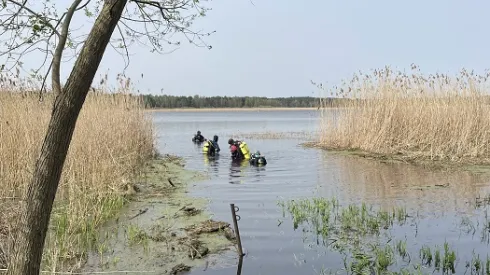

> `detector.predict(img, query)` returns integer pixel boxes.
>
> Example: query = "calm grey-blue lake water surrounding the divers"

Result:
[153,111,490,275]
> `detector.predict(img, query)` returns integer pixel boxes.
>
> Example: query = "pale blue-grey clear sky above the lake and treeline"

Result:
[0,0,490,97]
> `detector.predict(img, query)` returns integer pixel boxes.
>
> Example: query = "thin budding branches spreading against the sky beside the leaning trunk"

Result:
[0,0,213,98]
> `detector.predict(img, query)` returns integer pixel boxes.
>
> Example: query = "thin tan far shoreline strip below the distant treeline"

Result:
[145,107,320,112]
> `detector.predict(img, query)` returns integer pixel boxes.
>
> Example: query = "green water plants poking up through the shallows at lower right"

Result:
[278,198,490,274]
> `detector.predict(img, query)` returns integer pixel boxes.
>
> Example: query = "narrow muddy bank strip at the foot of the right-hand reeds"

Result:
[301,141,490,174]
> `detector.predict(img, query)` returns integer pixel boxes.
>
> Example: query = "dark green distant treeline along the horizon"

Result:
[143,95,340,108]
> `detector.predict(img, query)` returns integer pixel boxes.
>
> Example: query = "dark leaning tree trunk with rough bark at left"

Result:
[8,0,127,275]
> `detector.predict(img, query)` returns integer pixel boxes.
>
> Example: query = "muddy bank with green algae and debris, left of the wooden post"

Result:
[81,156,234,274]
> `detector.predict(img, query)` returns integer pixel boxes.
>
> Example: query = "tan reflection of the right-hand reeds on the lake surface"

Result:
[318,152,490,217]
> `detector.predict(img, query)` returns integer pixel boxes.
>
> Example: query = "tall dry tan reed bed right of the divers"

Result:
[319,65,490,163]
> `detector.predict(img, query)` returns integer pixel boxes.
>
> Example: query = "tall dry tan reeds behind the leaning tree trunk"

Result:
[0,74,154,271]
